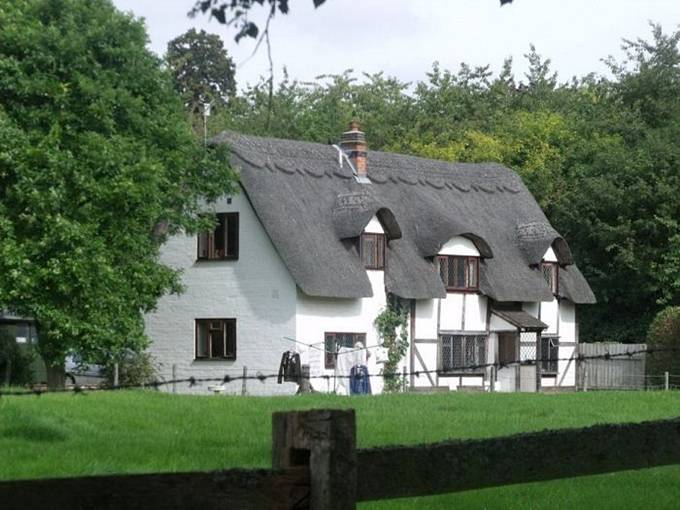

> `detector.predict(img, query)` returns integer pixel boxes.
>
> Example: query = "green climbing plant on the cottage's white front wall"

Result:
[374,296,408,393]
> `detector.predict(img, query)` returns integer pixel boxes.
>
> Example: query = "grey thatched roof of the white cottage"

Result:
[214,132,595,303]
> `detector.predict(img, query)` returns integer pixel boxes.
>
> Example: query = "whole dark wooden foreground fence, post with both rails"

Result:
[0,410,680,510]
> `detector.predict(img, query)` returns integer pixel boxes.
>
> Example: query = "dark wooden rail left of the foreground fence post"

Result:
[0,466,309,510]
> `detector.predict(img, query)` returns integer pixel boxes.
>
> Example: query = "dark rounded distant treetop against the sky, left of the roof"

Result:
[165,28,236,115]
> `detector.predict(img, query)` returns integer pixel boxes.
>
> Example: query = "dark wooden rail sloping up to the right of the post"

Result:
[357,419,680,501]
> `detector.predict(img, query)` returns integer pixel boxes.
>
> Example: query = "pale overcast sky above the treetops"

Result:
[114,0,680,87]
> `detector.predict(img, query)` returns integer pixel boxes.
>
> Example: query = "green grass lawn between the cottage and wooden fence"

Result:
[0,391,680,509]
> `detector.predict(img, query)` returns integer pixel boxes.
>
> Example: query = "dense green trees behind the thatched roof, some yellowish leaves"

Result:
[212,26,680,342]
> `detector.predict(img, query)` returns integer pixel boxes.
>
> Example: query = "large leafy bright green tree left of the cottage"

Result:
[0,0,233,374]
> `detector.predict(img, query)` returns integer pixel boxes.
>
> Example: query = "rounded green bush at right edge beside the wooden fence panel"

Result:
[646,306,680,376]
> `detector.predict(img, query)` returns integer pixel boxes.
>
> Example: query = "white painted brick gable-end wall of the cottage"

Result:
[146,189,297,395]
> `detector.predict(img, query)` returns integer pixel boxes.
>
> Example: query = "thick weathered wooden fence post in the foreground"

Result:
[272,409,357,510]
